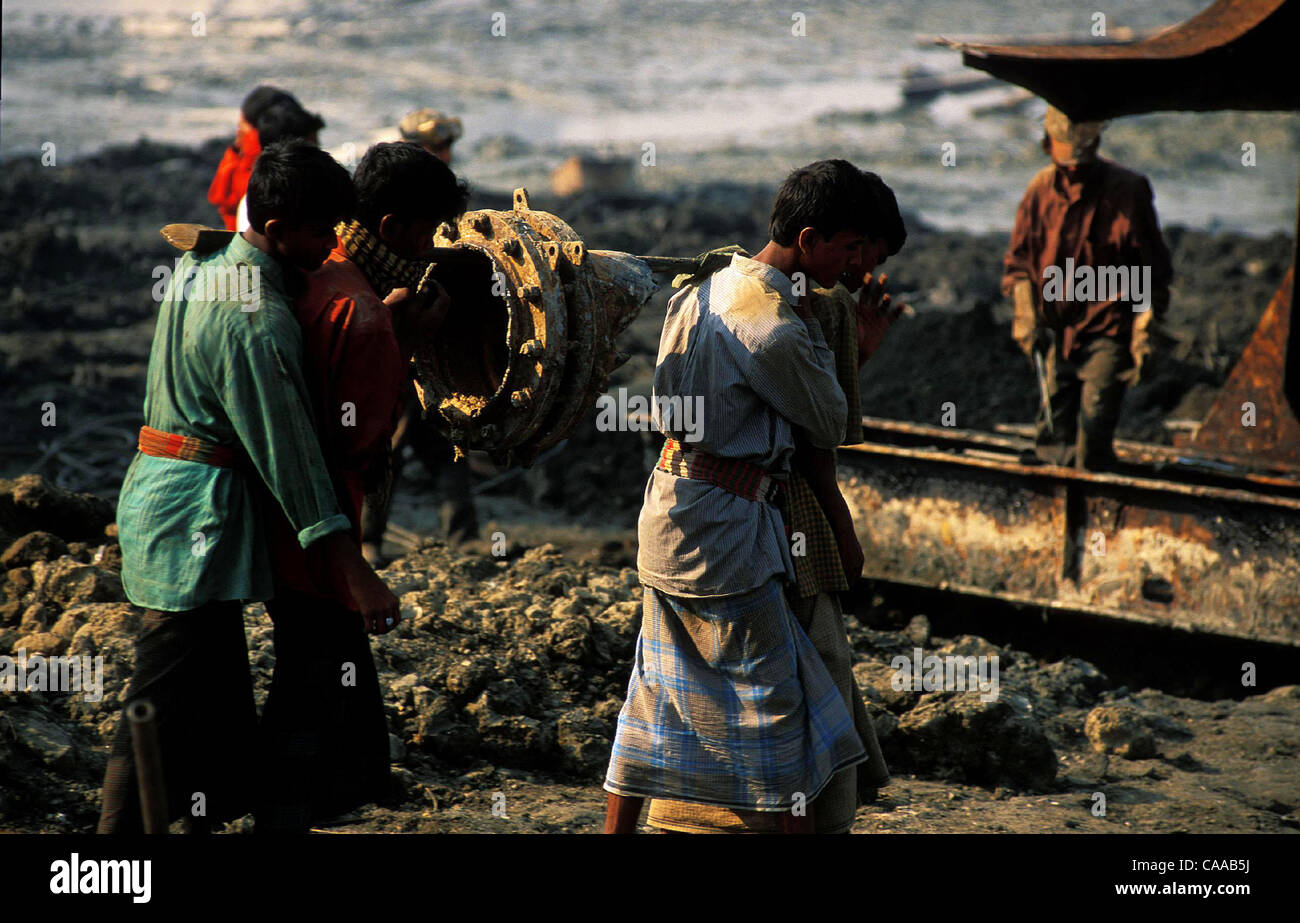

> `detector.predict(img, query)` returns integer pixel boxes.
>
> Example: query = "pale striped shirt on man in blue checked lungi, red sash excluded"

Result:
[637,254,848,597]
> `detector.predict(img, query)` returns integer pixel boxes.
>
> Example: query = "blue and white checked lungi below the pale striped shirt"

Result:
[605,580,866,811]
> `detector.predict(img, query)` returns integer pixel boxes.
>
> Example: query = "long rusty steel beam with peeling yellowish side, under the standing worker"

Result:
[840,417,1300,645]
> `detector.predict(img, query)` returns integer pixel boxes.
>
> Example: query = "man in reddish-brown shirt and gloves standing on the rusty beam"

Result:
[1002,107,1173,471]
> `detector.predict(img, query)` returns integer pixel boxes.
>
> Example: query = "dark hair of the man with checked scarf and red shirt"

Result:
[352,140,469,234]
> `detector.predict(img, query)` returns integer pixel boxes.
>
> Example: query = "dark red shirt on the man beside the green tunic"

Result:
[270,244,407,610]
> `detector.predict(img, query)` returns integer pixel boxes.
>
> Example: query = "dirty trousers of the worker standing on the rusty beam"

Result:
[1035,337,1132,471]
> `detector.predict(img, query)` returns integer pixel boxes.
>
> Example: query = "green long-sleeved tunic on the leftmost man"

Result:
[117,235,350,611]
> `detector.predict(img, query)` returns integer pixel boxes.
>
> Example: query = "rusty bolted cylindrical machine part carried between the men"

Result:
[415,189,657,465]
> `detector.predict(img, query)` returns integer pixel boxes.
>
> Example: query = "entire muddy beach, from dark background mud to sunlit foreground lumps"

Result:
[0,142,1300,833]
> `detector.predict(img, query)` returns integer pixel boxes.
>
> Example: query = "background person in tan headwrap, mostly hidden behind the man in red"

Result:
[361,108,478,566]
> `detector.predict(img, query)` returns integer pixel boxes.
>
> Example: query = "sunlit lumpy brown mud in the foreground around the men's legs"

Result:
[0,499,1300,835]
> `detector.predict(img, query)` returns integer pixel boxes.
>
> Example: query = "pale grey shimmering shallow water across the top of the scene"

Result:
[0,0,1300,234]
